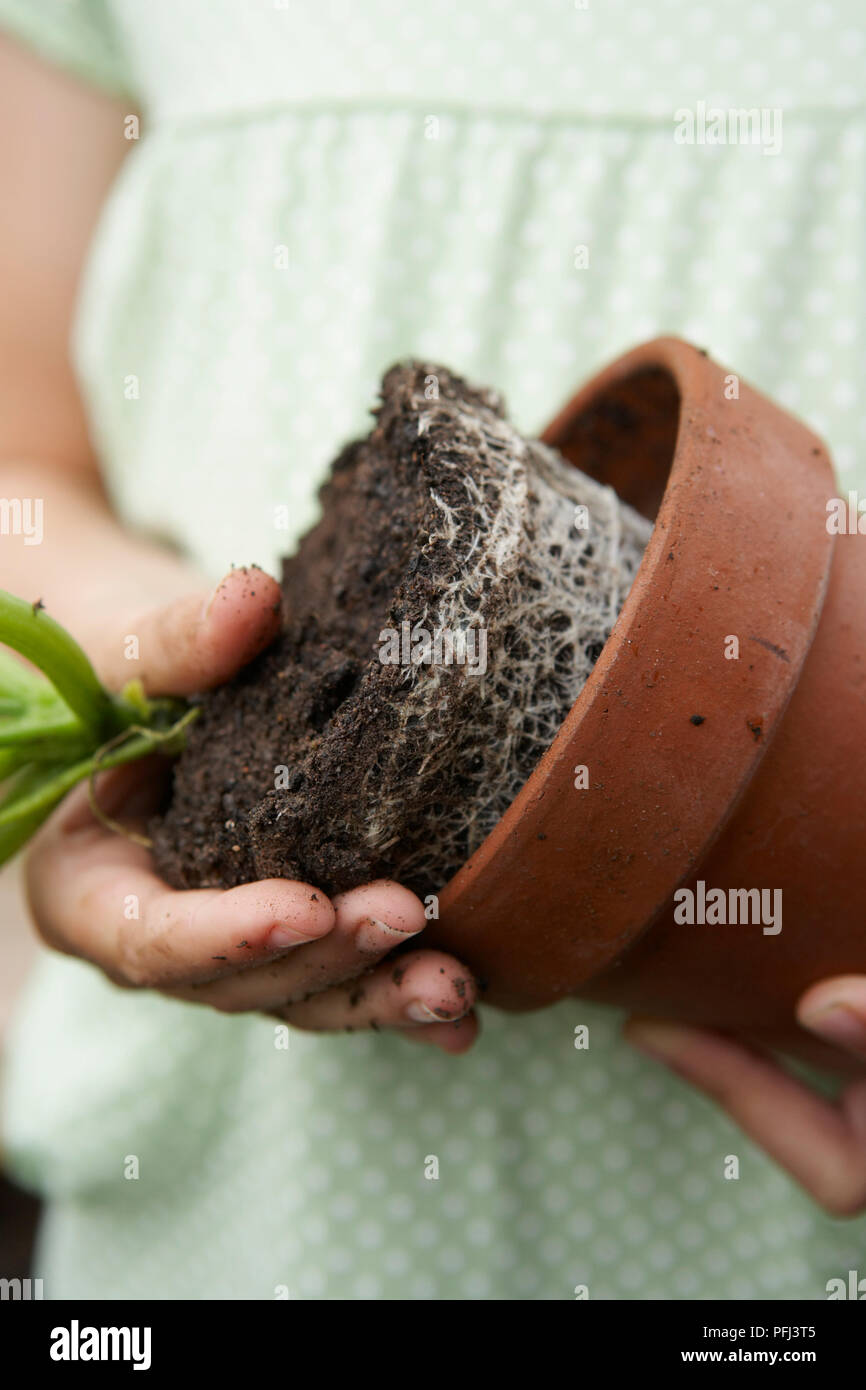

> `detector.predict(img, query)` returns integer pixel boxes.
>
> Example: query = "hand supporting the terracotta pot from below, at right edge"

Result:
[626,976,866,1216]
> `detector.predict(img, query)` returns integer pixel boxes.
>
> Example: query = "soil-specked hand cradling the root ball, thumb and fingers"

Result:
[28,571,478,1052]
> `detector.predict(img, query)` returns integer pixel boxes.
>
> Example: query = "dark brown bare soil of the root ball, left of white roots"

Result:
[152,364,517,892]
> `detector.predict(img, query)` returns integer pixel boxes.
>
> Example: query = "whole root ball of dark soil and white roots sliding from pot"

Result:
[152,363,646,897]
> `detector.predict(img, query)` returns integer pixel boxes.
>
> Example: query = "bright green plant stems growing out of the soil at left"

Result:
[0,589,199,865]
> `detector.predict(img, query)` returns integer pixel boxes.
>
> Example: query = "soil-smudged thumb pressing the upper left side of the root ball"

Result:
[95,569,281,695]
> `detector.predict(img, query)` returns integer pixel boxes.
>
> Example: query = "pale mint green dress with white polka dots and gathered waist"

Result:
[0,0,866,1300]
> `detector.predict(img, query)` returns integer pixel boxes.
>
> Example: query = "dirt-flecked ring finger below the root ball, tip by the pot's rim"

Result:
[271,951,475,1031]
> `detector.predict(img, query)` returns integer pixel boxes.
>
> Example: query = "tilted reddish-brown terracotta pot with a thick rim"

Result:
[430,338,866,1069]
